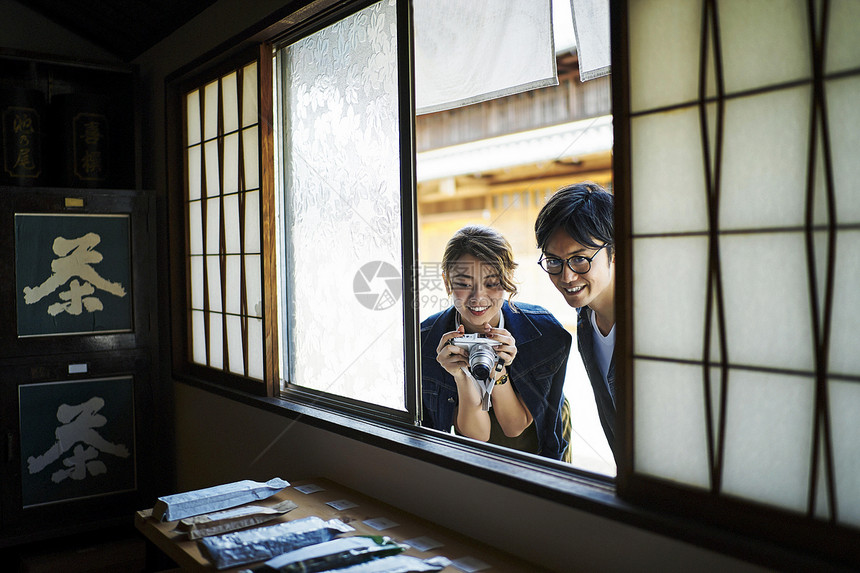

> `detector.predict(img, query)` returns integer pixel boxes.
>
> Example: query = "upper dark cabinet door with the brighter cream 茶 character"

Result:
[0,187,156,359]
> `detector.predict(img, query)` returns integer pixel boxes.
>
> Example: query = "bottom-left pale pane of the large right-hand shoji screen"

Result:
[633,360,710,488]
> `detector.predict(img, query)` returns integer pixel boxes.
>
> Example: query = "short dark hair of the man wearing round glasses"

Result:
[535,182,615,254]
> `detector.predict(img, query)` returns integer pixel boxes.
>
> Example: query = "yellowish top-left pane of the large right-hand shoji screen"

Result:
[627,0,702,112]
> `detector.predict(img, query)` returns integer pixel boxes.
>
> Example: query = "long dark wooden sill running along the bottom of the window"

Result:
[179,377,842,571]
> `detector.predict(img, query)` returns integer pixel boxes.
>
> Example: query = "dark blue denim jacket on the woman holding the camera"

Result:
[421,301,572,460]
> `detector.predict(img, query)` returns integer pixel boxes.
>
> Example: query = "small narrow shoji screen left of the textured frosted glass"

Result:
[185,63,263,380]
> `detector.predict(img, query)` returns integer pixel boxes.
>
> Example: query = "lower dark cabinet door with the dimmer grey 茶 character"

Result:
[0,350,159,547]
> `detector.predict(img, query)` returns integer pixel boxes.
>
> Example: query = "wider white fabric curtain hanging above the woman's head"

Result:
[413,0,558,114]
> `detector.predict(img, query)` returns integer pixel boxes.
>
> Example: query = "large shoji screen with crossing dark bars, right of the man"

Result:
[626,0,860,526]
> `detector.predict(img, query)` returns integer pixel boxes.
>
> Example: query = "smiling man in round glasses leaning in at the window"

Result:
[535,183,618,459]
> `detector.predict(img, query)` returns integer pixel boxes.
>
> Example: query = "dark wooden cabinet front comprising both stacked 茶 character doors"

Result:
[0,187,163,547]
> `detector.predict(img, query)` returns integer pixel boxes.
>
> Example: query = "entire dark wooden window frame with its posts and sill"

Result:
[159,0,858,569]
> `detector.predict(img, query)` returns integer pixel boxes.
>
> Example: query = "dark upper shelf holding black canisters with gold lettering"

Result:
[0,48,140,189]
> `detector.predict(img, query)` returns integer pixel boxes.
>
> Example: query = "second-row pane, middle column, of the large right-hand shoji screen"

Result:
[720,86,810,229]
